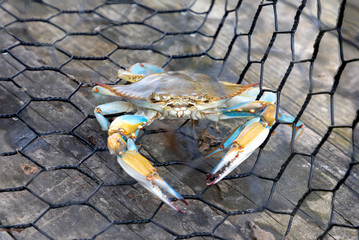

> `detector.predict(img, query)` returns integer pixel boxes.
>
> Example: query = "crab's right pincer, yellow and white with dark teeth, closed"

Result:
[206,121,269,186]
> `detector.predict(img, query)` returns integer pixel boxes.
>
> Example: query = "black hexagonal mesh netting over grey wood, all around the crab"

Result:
[0,0,359,239]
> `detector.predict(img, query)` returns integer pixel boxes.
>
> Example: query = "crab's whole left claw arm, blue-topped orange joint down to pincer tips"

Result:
[108,115,188,213]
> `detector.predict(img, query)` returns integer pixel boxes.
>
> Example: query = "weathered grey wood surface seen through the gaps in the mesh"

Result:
[0,1,359,239]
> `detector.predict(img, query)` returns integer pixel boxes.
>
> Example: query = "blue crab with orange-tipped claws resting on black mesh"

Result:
[93,63,304,212]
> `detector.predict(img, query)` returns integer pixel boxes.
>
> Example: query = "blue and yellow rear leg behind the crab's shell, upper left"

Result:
[117,63,164,82]
